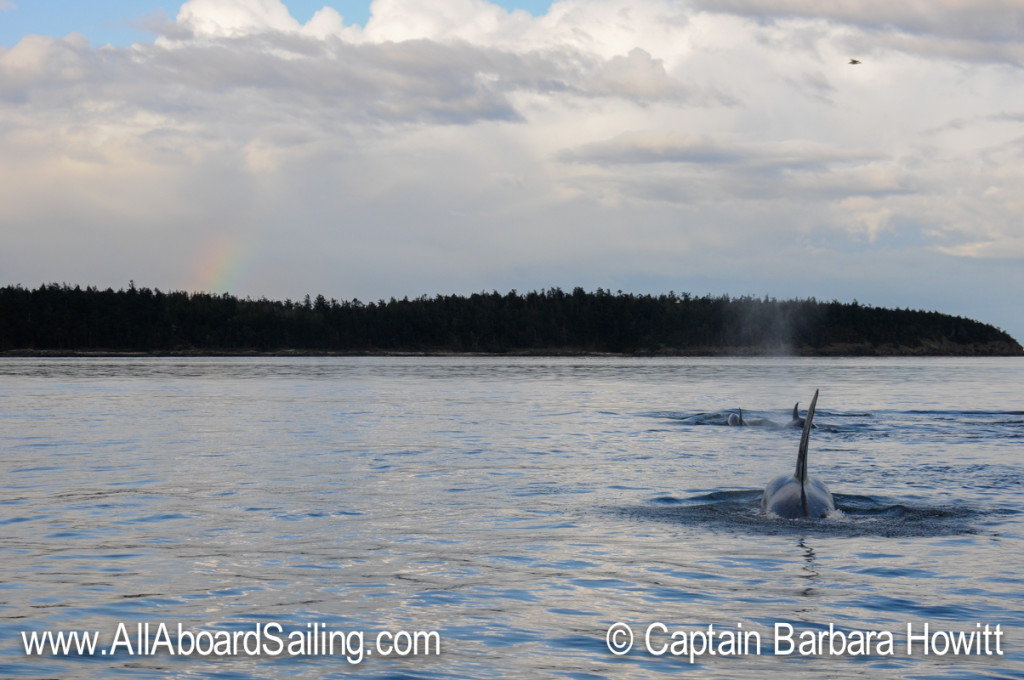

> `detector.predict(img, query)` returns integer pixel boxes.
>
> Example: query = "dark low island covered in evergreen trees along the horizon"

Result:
[0,282,1024,355]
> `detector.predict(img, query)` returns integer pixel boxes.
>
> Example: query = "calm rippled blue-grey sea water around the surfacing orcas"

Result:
[0,357,1024,680]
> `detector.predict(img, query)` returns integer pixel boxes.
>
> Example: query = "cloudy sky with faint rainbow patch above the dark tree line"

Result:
[0,0,1024,340]
